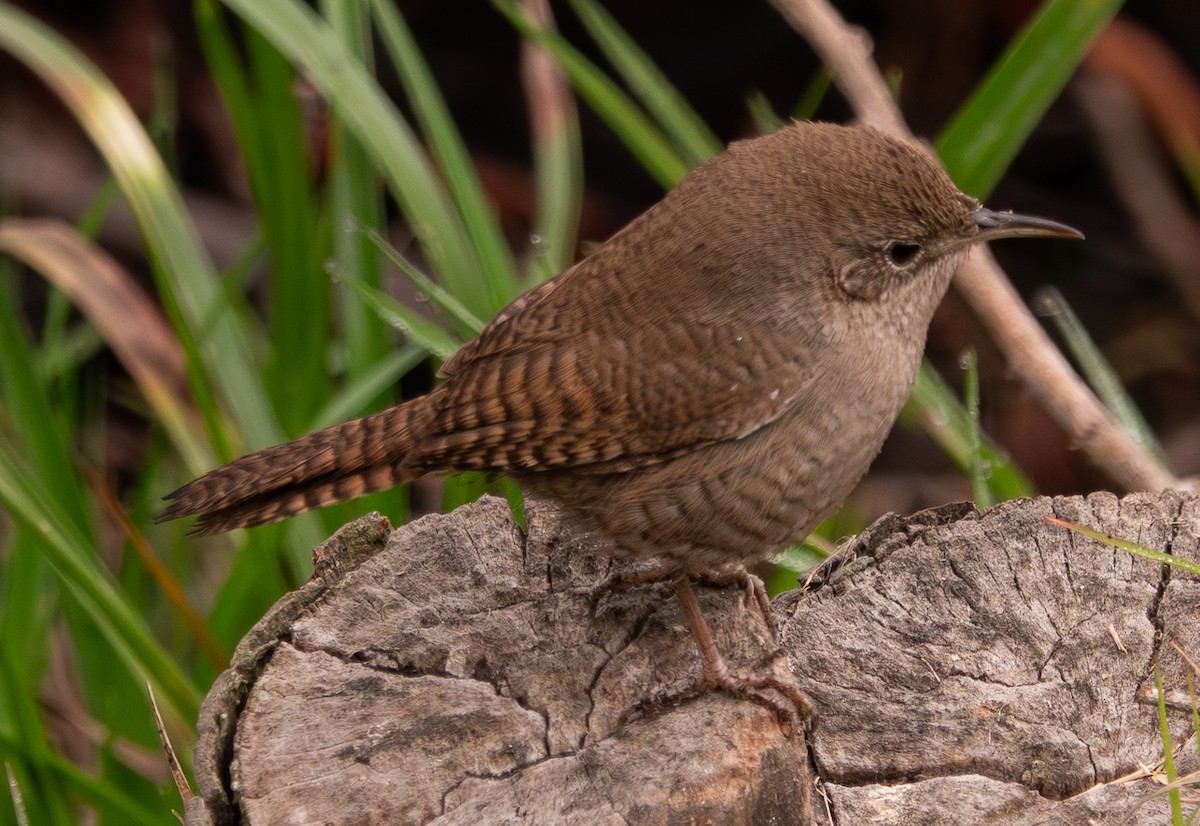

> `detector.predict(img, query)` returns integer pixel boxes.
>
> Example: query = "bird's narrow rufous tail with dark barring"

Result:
[157,396,431,534]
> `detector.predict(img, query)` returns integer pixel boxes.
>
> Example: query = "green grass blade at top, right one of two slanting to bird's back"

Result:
[569,0,724,166]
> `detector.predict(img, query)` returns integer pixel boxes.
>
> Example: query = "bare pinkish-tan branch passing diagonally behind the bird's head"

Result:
[770,0,1190,490]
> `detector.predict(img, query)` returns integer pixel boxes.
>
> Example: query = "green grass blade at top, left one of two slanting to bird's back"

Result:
[492,0,691,188]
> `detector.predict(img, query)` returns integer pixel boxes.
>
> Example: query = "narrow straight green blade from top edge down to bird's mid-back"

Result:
[372,0,521,316]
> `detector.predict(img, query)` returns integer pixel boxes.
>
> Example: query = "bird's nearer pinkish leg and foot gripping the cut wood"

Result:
[641,573,812,732]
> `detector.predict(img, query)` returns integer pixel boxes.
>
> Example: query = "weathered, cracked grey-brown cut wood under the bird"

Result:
[187,492,1200,826]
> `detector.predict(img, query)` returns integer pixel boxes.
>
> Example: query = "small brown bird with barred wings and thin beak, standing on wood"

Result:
[162,122,1081,716]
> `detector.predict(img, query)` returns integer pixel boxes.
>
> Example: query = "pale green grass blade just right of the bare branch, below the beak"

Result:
[1034,287,1169,468]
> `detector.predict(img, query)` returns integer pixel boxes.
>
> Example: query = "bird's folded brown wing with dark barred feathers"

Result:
[406,312,812,472]
